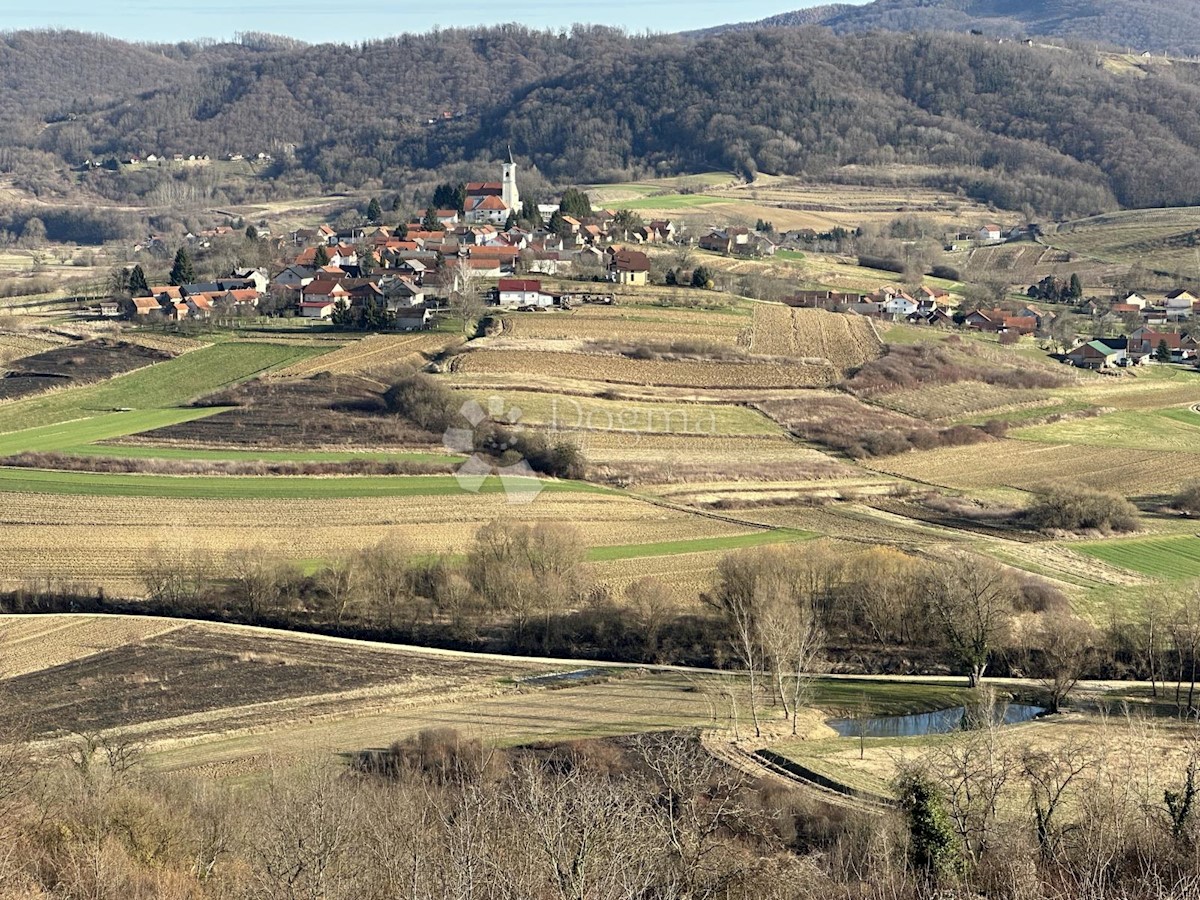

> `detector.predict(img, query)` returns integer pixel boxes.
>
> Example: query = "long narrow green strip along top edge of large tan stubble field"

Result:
[0,468,613,502]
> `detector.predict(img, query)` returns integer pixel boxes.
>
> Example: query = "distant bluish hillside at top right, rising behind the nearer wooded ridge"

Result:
[712,0,1200,55]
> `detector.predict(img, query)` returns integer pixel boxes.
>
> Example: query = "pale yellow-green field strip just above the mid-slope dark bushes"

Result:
[453,391,784,436]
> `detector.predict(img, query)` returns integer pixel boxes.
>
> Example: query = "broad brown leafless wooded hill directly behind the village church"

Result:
[7,25,1200,216]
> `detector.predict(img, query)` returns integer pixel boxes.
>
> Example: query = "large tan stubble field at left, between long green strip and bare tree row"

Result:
[0,493,746,593]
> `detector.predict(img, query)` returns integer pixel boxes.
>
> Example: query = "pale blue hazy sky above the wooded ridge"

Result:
[0,0,862,43]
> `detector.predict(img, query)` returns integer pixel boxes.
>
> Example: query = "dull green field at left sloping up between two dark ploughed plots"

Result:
[0,342,328,434]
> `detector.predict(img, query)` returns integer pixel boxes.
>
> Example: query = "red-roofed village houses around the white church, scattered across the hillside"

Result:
[108,160,1200,371]
